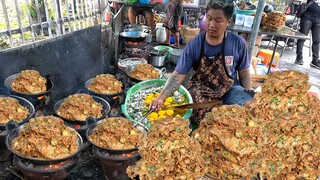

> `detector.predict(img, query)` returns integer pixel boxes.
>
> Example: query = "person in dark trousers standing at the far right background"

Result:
[295,0,320,69]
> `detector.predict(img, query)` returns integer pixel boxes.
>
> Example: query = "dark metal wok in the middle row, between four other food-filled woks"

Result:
[53,95,111,125]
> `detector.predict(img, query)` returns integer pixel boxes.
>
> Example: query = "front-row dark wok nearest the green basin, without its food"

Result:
[86,119,148,154]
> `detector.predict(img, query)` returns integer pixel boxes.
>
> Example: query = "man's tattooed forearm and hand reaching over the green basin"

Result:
[150,71,186,109]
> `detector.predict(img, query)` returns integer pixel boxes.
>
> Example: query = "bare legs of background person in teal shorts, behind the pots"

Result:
[128,6,155,30]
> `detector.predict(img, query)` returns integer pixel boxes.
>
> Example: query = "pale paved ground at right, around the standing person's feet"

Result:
[260,41,320,89]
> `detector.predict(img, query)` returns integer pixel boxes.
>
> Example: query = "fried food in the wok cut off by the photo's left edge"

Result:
[0,97,29,124]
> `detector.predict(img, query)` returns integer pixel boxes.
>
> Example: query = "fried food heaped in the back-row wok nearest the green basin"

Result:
[88,74,122,94]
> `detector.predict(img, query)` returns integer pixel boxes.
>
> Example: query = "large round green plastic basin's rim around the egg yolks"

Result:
[121,79,193,129]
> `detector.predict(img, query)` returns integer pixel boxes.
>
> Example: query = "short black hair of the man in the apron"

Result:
[206,0,234,19]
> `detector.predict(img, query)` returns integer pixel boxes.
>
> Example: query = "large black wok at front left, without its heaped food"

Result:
[6,121,83,165]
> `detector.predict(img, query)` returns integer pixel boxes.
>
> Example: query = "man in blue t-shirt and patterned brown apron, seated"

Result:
[150,0,253,124]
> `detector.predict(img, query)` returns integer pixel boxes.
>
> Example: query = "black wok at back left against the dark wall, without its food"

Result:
[4,74,53,106]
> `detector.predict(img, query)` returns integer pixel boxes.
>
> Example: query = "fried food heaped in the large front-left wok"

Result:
[11,116,80,159]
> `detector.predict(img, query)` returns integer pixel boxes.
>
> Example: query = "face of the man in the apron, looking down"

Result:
[206,9,231,37]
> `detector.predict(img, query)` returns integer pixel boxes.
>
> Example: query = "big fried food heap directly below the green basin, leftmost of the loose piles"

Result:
[127,117,207,180]
